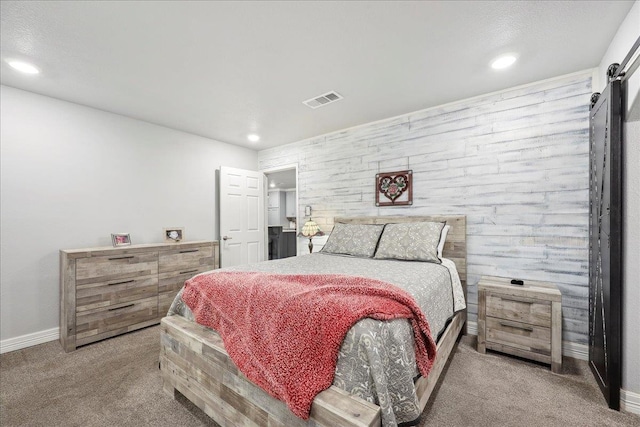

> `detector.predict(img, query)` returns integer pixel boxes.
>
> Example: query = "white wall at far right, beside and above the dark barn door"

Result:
[594,1,640,402]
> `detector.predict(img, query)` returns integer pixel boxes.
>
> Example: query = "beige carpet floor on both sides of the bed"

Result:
[0,326,640,427]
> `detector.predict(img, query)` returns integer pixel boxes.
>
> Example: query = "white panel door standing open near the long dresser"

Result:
[220,166,266,267]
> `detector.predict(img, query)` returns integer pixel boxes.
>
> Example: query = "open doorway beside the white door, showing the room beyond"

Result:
[263,165,298,259]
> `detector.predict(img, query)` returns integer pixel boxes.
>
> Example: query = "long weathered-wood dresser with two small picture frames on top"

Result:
[60,241,220,352]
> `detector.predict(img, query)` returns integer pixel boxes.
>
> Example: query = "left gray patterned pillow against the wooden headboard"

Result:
[320,224,384,258]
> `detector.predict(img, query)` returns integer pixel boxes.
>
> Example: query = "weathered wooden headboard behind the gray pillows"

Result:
[334,215,467,290]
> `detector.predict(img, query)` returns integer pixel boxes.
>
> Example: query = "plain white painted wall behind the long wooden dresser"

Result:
[0,86,258,342]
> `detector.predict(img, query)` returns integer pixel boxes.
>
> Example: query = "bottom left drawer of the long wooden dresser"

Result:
[76,296,158,346]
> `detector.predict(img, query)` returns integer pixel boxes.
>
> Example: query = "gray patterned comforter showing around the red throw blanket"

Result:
[168,253,465,427]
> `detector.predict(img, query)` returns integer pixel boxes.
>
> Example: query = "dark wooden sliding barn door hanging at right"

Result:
[589,80,622,410]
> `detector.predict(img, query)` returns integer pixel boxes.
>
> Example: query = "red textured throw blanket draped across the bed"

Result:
[182,272,436,419]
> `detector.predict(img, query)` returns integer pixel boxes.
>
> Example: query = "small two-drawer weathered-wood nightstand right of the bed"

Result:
[478,276,562,373]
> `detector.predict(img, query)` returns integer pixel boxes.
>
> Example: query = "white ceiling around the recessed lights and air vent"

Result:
[0,1,633,150]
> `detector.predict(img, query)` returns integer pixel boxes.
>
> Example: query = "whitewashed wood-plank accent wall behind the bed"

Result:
[258,71,592,344]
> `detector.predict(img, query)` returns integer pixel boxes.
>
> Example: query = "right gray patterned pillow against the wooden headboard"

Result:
[374,222,444,264]
